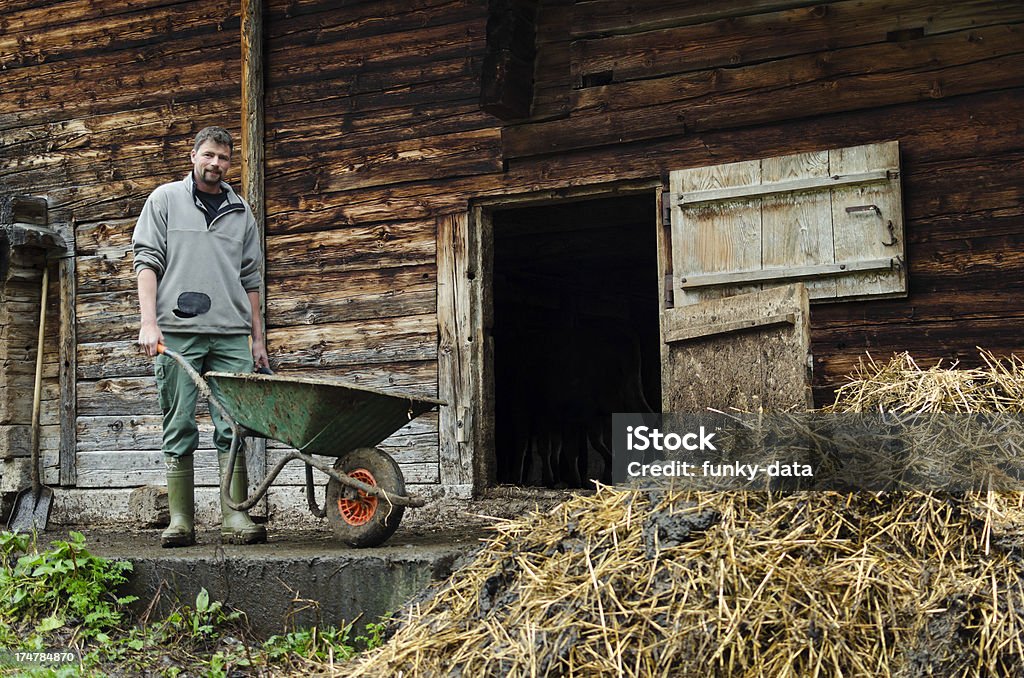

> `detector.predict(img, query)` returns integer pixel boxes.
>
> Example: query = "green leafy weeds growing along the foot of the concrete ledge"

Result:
[0,533,385,678]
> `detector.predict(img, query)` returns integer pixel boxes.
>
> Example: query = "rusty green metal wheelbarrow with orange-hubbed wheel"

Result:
[157,345,445,547]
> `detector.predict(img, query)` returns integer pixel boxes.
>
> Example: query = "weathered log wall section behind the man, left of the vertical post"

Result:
[0,0,247,497]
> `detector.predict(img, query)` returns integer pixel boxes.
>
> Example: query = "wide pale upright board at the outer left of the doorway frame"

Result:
[437,213,474,485]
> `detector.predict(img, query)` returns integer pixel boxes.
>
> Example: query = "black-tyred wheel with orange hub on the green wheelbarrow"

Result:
[326,448,406,548]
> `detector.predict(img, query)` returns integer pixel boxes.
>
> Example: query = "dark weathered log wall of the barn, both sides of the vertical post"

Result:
[0,0,1024,510]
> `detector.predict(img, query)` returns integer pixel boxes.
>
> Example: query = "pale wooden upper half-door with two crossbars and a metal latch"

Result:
[668,141,906,306]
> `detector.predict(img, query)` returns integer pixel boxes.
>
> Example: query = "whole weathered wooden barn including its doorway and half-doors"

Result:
[0,0,1024,522]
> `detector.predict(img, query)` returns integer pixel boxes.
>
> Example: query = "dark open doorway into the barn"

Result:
[493,192,660,488]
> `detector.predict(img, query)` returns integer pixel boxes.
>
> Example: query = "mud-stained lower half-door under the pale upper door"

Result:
[662,283,813,412]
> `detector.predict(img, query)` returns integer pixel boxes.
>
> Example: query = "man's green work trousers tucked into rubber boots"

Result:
[156,333,253,457]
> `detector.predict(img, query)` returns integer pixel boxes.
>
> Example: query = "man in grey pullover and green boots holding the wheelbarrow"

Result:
[132,127,268,547]
